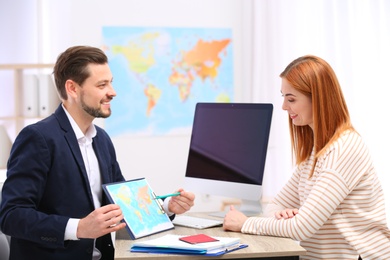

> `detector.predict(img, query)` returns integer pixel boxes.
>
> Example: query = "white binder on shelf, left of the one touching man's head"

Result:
[21,74,39,117]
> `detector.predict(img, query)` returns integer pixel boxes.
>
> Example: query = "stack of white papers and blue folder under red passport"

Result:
[130,234,248,256]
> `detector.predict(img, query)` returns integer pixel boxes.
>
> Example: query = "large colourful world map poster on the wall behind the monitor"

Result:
[102,26,234,137]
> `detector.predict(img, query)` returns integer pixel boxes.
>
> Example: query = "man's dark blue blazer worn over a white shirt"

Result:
[0,105,124,260]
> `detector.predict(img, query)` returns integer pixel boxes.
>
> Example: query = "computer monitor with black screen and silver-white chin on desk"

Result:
[184,103,273,215]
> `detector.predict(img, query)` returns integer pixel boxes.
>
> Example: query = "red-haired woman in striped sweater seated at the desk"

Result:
[223,56,390,260]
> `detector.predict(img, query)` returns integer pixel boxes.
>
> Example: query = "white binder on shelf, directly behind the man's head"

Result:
[38,74,60,117]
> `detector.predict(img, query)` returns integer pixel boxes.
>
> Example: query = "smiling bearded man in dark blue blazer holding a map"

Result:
[0,46,194,260]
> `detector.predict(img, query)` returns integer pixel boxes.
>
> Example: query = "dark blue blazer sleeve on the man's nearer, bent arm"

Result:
[0,126,69,248]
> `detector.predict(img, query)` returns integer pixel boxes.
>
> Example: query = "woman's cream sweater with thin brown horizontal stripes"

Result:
[241,131,390,260]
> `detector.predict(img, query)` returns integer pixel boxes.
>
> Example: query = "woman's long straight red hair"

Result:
[280,55,353,175]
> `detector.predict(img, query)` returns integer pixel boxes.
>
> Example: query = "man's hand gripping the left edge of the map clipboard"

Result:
[77,204,126,238]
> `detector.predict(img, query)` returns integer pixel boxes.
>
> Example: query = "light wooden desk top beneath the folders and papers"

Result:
[115,214,306,260]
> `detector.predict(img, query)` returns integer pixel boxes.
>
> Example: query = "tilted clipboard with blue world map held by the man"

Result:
[103,178,174,239]
